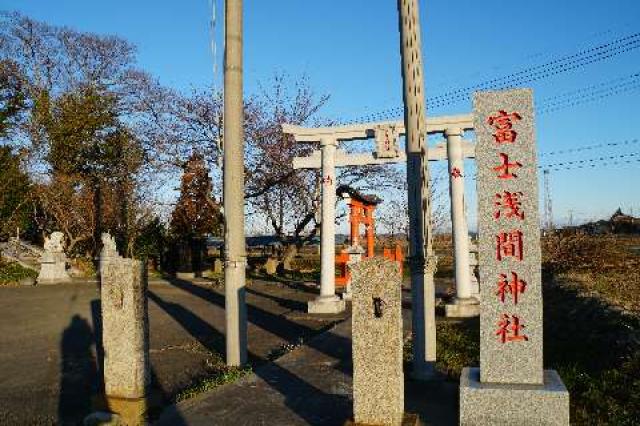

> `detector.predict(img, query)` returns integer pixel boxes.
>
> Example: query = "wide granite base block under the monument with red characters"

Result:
[460,367,569,426]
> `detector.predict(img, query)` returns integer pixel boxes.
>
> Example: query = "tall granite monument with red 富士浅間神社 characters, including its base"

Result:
[460,89,569,425]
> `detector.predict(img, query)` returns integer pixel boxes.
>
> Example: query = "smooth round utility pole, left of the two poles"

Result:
[223,0,247,366]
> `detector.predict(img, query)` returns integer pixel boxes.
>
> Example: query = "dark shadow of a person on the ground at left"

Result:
[58,315,99,425]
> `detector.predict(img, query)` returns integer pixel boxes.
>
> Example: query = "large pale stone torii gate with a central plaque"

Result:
[282,114,476,313]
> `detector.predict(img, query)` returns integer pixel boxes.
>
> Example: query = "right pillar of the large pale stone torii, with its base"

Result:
[444,128,480,317]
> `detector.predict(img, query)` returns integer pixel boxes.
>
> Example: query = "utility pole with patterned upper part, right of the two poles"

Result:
[398,0,436,379]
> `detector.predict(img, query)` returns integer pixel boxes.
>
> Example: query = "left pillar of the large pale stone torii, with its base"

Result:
[307,138,345,314]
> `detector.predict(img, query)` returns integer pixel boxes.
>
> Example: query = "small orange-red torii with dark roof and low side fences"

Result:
[336,185,404,288]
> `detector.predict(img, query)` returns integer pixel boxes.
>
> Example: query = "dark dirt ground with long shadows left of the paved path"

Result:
[0,274,346,425]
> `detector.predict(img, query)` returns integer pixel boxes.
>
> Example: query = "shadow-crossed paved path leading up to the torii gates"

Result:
[157,302,458,426]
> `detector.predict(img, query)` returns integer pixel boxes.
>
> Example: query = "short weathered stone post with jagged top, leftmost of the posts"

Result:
[100,234,150,424]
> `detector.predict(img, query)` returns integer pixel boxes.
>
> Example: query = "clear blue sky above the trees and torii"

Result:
[0,0,640,230]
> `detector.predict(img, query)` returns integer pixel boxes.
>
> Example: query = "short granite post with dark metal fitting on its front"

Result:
[351,257,404,425]
